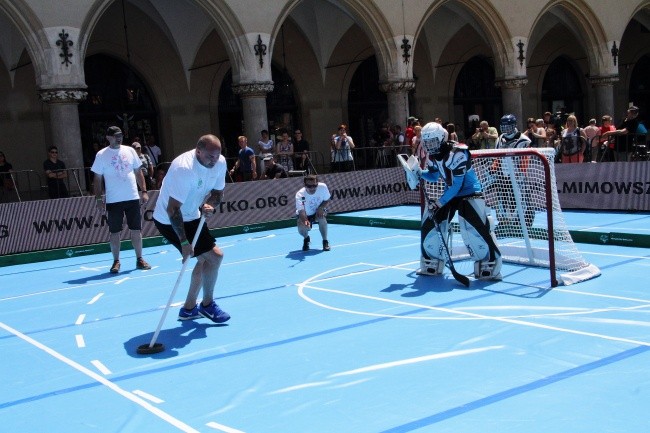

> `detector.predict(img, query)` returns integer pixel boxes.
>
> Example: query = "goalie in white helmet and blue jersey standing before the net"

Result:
[400,122,501,280]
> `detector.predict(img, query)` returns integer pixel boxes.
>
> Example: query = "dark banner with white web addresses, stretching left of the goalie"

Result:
[0,168,408,255]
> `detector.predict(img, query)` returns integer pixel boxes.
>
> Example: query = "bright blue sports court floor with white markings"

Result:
[0,206,650,433]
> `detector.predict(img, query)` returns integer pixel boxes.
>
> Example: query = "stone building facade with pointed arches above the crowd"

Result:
[0,0,650,178]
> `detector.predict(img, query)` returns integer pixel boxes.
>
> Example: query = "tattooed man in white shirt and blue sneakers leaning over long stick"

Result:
[153,134,230,323]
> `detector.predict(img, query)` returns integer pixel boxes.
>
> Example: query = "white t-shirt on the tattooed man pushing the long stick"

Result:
[153,149,227,224]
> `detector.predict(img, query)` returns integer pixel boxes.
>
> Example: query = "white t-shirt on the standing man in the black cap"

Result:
[90,145,142,203]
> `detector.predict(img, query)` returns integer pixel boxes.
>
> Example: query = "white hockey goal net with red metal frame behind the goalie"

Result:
[422,148,600,287]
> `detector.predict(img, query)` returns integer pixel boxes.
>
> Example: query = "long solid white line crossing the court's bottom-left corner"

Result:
[0,322,200,433]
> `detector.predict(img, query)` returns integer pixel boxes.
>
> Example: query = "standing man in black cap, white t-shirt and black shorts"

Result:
[90,126,151,274]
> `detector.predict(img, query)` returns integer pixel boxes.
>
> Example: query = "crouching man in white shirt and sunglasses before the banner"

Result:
[296,174,331,251]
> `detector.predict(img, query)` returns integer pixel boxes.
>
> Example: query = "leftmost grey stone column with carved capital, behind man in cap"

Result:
[39,89,88,191]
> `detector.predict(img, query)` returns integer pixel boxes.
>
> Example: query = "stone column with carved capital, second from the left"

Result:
[232,81,273,149]
